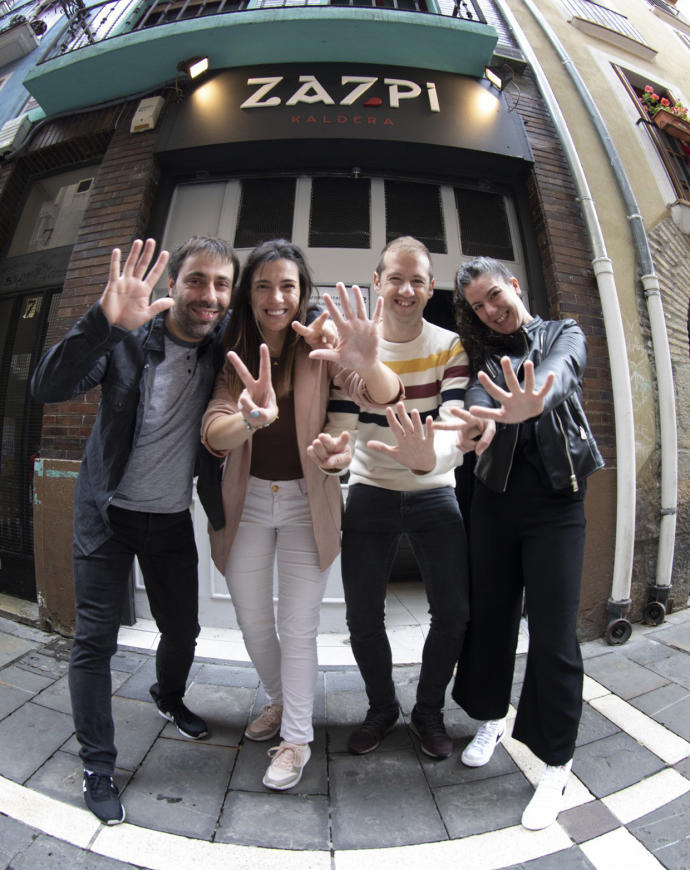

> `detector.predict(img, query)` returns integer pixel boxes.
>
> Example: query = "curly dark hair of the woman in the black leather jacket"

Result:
[453,257,513,376]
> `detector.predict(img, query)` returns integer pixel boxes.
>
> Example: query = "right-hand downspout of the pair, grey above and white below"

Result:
[512,0,678,625]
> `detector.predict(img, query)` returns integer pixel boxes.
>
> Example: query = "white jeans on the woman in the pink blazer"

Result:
[225,476,328,743]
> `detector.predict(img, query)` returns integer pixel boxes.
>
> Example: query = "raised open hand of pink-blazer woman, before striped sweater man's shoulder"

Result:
[309,283,383,377]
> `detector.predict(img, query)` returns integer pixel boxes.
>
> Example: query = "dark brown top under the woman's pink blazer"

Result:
[249,390,304,480]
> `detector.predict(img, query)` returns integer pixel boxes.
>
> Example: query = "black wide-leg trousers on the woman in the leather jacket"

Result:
[453,460,585,765]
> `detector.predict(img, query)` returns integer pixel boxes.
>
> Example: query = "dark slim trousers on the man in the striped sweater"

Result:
[342,484,469,712]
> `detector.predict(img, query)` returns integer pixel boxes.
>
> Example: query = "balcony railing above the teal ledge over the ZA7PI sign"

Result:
[40,0,486,63]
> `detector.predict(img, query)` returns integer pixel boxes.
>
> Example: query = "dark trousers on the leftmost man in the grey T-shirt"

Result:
[69,508,199,774]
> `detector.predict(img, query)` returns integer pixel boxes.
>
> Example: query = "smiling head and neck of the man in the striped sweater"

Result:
[374,248,434,341]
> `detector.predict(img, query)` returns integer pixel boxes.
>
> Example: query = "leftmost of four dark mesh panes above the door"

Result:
[235,178,295,248]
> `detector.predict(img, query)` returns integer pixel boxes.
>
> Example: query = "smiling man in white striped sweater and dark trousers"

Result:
[310,236,469,758]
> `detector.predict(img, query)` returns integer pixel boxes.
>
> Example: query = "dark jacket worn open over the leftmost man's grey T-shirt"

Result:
[31,303,226,553]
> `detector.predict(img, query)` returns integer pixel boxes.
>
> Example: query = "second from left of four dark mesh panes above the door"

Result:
[309,178,370,248]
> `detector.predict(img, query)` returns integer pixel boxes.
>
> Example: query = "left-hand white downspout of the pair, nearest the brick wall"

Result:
[494,0,636,643]
